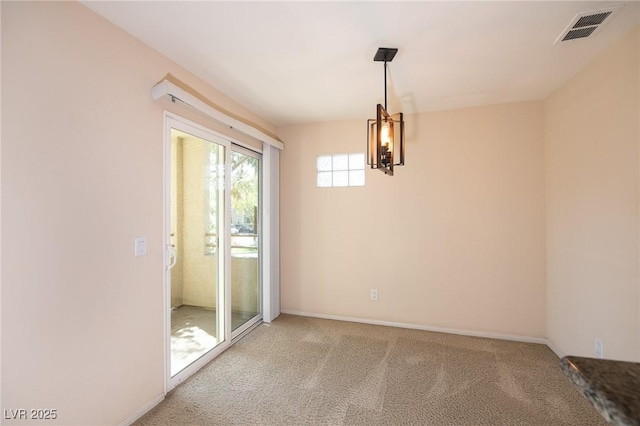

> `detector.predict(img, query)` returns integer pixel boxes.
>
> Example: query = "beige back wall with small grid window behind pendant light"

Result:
[278,102,546,337]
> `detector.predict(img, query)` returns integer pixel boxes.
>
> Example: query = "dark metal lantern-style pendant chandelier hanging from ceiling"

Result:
[367,47,404,176]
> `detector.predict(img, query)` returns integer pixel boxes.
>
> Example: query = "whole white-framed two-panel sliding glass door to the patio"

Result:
[165,115,262,390]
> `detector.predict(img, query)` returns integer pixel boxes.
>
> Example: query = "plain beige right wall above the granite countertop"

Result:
[545,26,640,361]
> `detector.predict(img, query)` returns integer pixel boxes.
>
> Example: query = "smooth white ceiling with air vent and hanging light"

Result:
[83,1,640,126]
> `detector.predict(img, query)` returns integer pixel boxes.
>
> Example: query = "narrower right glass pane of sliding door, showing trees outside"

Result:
[231,146,261,335]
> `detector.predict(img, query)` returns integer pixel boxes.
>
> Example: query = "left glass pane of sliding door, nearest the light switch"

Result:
[169,128,226,377]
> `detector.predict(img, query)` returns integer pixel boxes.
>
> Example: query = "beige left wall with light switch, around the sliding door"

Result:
[0,2,274,425]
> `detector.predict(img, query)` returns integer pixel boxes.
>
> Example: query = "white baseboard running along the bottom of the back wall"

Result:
[282,309,558,348]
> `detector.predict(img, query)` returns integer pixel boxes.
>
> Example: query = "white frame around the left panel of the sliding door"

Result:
[162,111,231,394]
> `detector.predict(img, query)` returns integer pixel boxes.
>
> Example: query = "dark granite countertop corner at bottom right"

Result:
[560,356,640,426]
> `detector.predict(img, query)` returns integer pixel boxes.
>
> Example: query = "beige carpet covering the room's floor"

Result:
[136,315,606,426]
